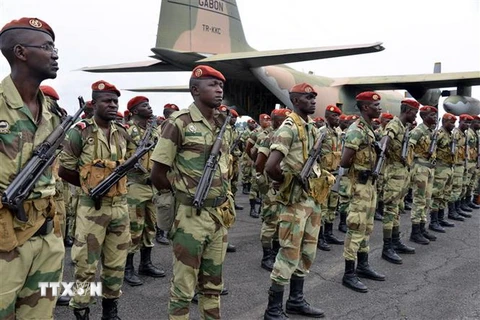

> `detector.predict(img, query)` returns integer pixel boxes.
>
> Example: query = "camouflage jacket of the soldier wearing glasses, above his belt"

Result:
[0,76,61,199]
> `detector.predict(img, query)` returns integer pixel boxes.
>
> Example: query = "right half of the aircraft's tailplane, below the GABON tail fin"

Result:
[196,42,385,68]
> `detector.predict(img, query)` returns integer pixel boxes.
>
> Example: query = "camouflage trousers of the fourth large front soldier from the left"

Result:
[270,197,322,285]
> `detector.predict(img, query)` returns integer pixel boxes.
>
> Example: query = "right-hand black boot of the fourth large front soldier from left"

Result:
[285,276,325,318]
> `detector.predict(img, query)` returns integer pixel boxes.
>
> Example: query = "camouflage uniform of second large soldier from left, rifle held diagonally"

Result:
[60,118,135,309]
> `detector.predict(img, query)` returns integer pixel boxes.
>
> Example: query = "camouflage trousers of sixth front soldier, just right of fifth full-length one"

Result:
[382,162,410,230]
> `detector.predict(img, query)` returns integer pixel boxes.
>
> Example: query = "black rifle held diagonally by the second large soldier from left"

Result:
[89,130,155,210]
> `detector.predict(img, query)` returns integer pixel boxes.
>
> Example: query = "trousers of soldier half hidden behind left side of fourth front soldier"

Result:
[260,189,283,248]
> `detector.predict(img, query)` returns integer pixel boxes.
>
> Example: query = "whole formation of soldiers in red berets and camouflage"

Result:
[0,18,480,319]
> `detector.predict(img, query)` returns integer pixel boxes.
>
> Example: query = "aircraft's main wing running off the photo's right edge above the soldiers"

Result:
[331,71,480,90]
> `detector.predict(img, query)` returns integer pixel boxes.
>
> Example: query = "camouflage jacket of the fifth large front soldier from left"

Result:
[345,117,377,174]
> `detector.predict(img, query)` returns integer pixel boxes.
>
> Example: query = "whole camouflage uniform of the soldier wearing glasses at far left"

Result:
[0,76,65,319]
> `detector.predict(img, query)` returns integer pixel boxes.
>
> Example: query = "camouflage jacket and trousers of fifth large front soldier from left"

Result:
[343,117,377,261]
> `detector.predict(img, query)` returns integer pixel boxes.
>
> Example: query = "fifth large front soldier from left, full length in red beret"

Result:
[338,91,385,292]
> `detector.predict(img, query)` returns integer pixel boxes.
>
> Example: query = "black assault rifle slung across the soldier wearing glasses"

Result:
[2,96,85,222]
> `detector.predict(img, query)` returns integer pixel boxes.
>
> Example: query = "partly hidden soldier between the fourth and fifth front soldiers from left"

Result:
[318,105,343,251]
